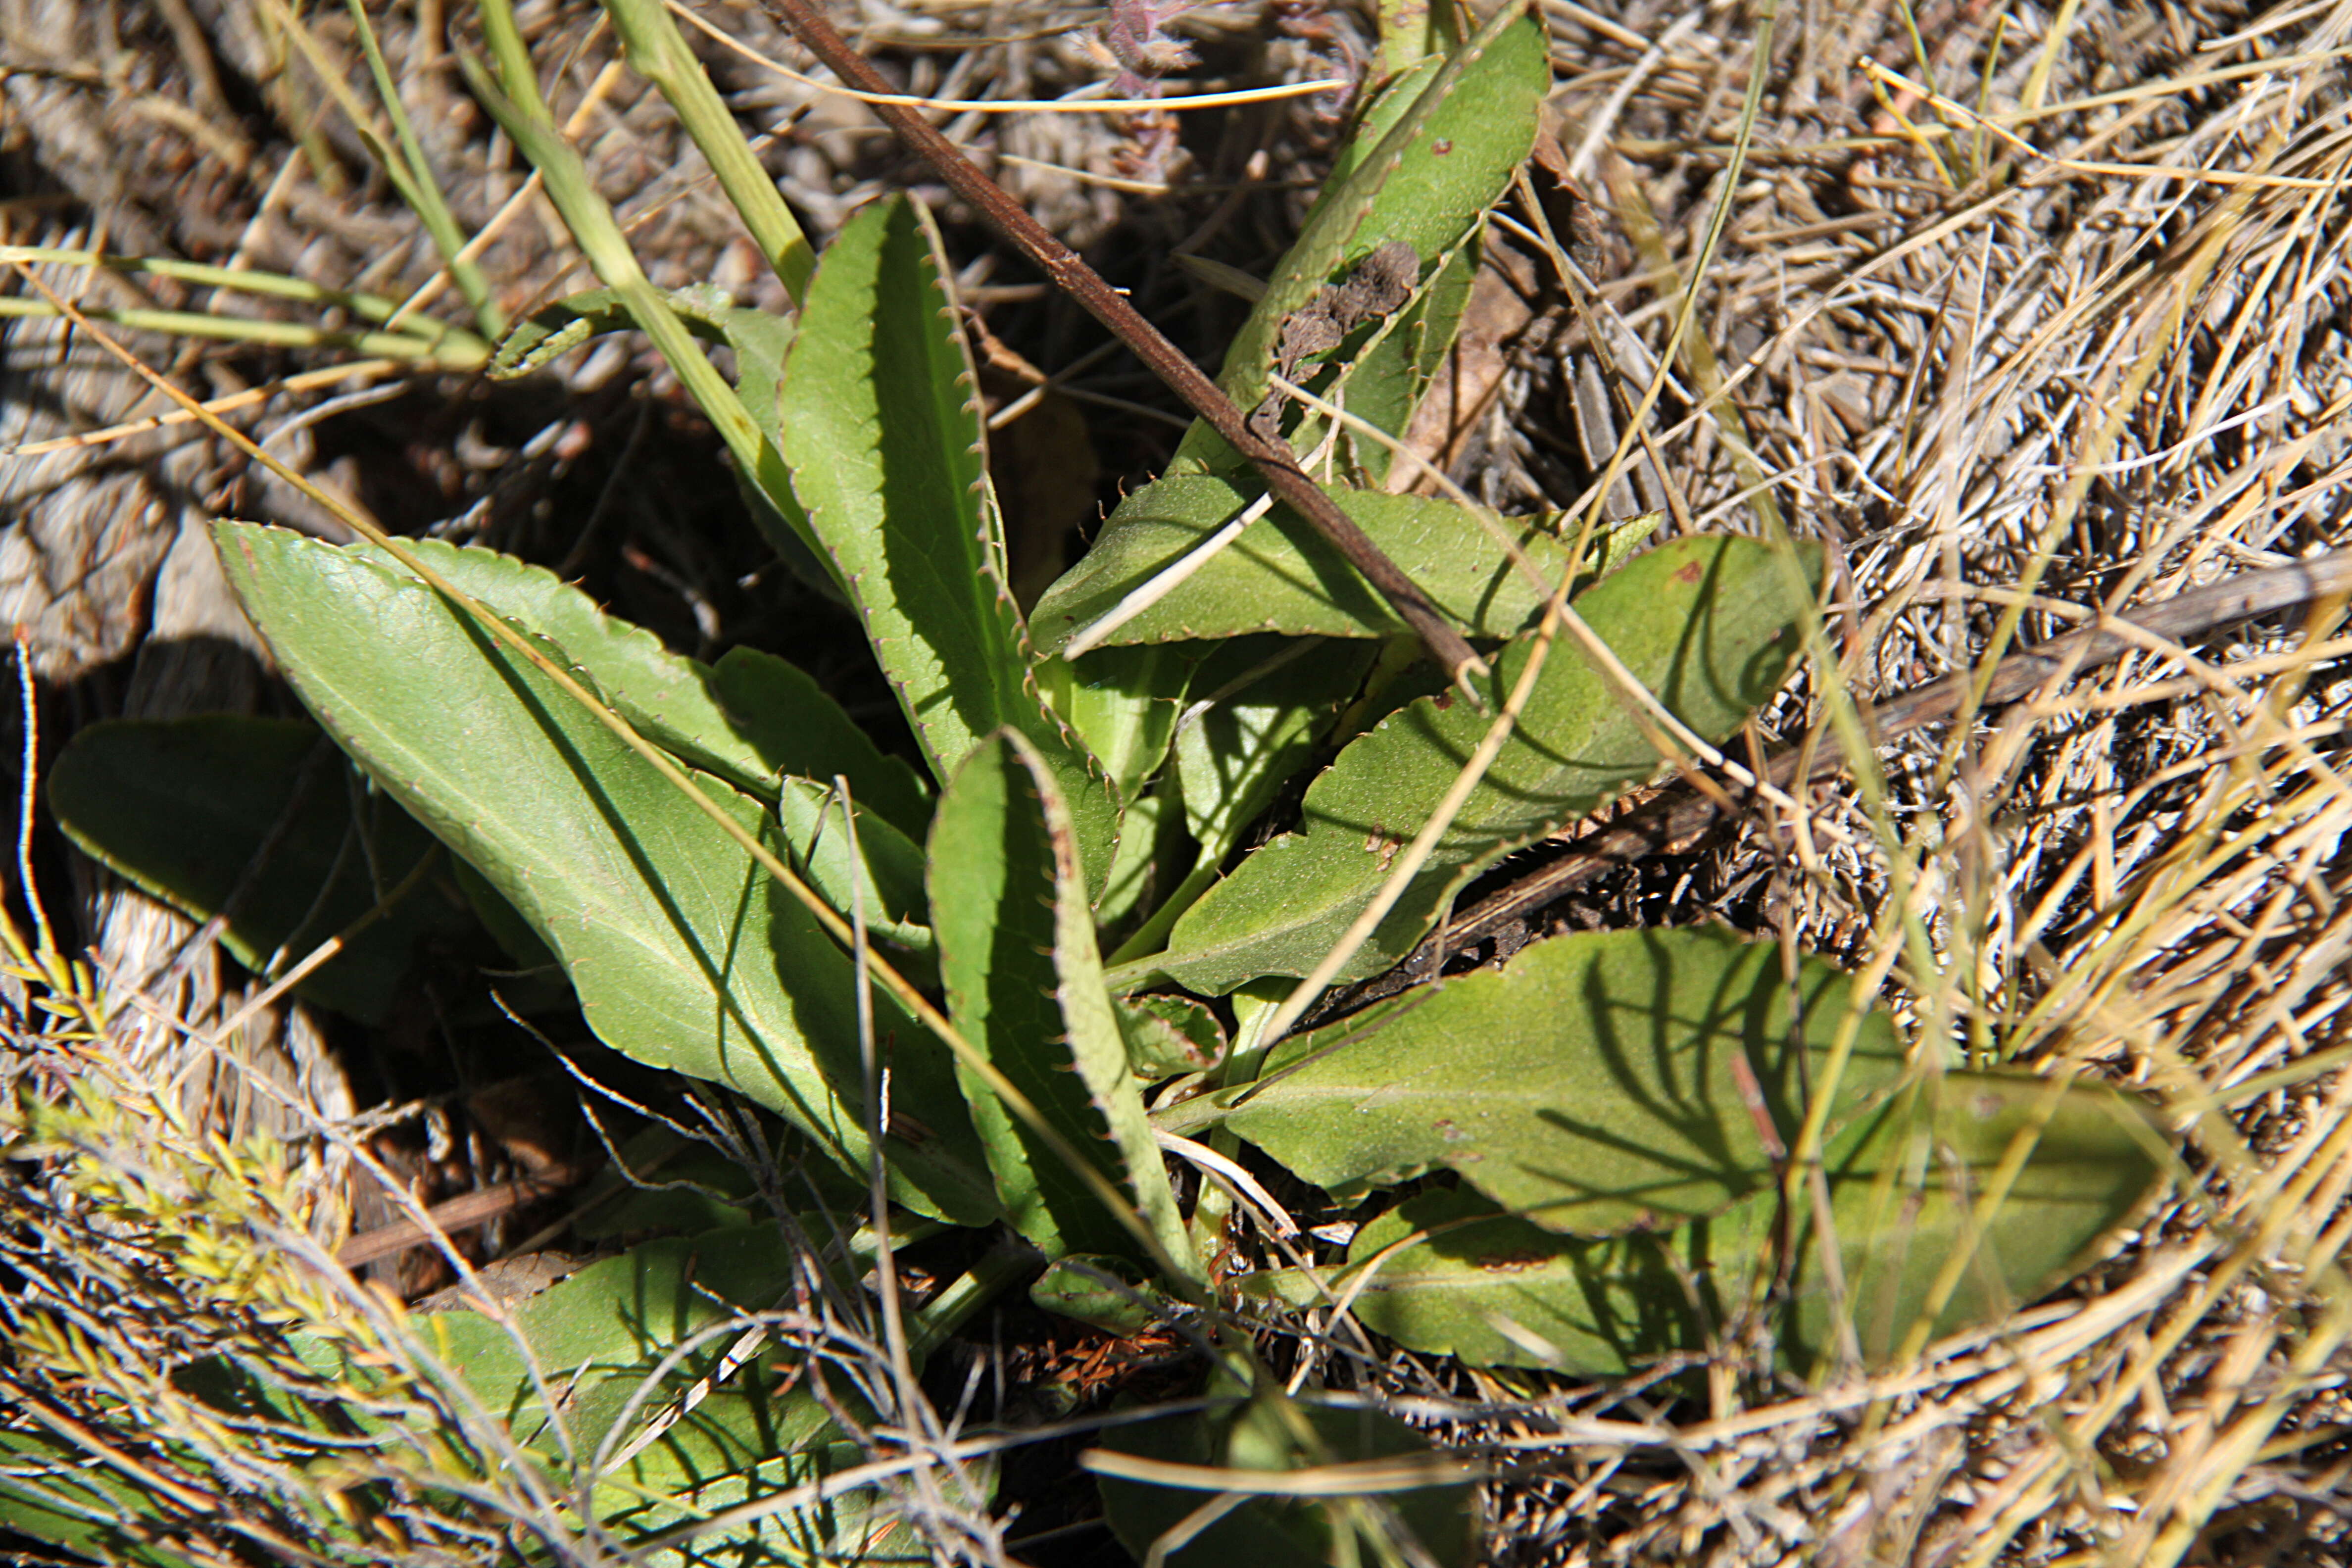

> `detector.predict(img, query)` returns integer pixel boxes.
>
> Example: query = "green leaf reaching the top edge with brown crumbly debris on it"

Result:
[1169,7,1550,473]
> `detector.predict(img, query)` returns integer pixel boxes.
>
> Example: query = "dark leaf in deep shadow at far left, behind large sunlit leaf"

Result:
[49,715,480,1023]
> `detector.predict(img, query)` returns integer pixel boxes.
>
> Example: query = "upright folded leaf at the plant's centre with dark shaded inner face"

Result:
[931,731,1197,1274]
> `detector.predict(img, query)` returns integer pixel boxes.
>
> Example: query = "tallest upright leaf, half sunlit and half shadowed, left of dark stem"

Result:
[779,197,1117,891]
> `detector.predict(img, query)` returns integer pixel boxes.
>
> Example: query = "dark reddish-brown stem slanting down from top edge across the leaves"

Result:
[762,0,1486,698]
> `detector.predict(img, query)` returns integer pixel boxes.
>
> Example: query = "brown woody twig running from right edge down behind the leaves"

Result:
[1317,550,2352,1023]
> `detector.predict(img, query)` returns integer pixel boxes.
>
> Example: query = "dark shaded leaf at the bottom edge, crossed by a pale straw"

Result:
[1096,1389,1477,1568]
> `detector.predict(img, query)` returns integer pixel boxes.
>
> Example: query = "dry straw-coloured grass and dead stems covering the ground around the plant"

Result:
[0,0,2352,1566]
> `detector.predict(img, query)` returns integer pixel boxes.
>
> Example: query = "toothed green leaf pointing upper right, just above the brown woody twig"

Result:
[1155,539,1820,992]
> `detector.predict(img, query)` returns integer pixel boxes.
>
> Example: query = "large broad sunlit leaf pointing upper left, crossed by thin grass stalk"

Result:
[219,524,990,1220]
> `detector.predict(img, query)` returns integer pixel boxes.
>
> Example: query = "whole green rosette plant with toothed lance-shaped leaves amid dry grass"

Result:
[9,4,2161,1561]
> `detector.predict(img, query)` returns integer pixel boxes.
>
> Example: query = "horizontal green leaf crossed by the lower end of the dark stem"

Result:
[1030,475,1569,658]
